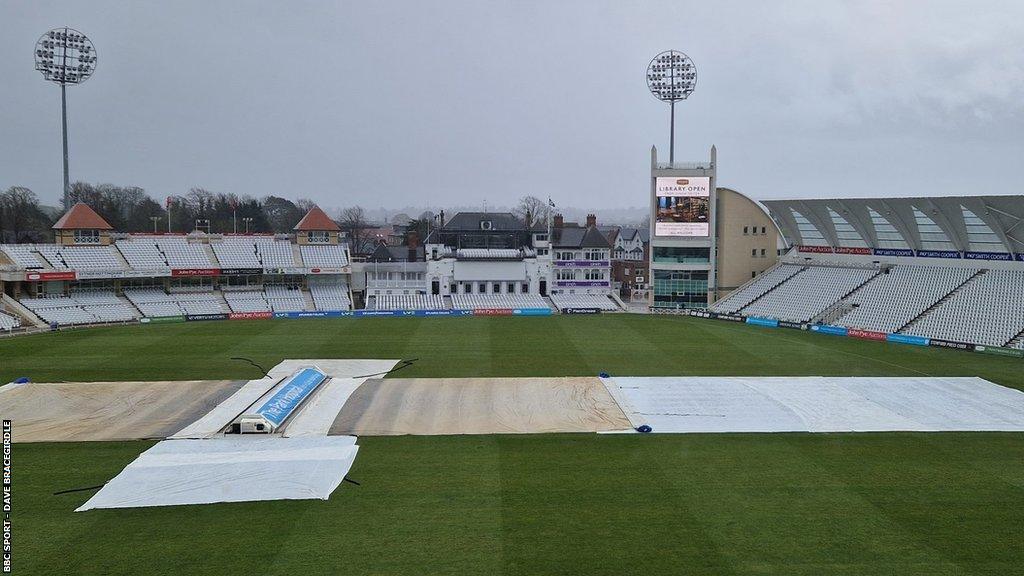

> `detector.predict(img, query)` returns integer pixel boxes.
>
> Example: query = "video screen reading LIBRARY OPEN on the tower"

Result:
[654,176,711,237]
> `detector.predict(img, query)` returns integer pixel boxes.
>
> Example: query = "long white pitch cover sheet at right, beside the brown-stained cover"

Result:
[605,376,1024,433]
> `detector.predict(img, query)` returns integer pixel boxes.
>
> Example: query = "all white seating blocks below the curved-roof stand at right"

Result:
[712,264,1024,349]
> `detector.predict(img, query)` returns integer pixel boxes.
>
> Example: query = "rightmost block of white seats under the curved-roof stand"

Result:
[902,270,1024,346]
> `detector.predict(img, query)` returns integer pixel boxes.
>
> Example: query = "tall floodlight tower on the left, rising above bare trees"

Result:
[36,27,96,210]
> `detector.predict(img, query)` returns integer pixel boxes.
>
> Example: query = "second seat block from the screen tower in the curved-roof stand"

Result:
[741,266,879,322]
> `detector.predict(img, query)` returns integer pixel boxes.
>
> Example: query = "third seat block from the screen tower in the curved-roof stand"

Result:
[833,265,978,333]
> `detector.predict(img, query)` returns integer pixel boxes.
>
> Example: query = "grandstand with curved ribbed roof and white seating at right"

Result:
[710,196,1024,351]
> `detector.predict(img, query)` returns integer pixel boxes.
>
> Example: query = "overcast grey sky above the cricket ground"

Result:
[0,0,1024,208]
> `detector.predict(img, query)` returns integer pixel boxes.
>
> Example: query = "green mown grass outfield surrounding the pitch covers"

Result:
[6,315,1024,575]
